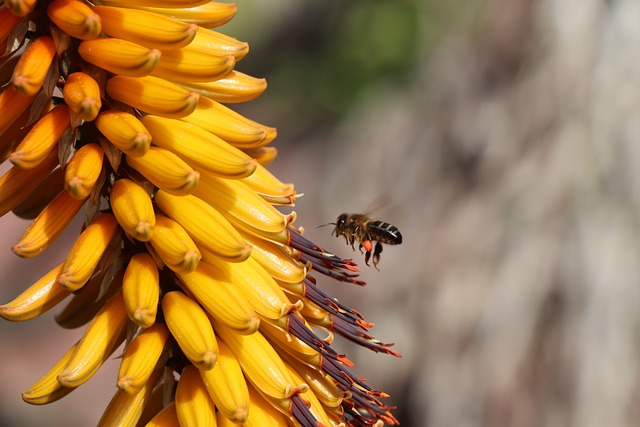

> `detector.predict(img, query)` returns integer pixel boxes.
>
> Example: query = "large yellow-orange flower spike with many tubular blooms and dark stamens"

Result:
[0,0,399,427]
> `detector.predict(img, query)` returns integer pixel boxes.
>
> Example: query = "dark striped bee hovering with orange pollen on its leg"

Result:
[319,213,402,271]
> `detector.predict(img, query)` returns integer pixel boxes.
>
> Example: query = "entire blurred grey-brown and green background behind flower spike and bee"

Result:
[0,0,640,427]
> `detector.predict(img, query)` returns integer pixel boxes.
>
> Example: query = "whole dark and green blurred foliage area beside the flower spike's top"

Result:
[225,0,440,122]
